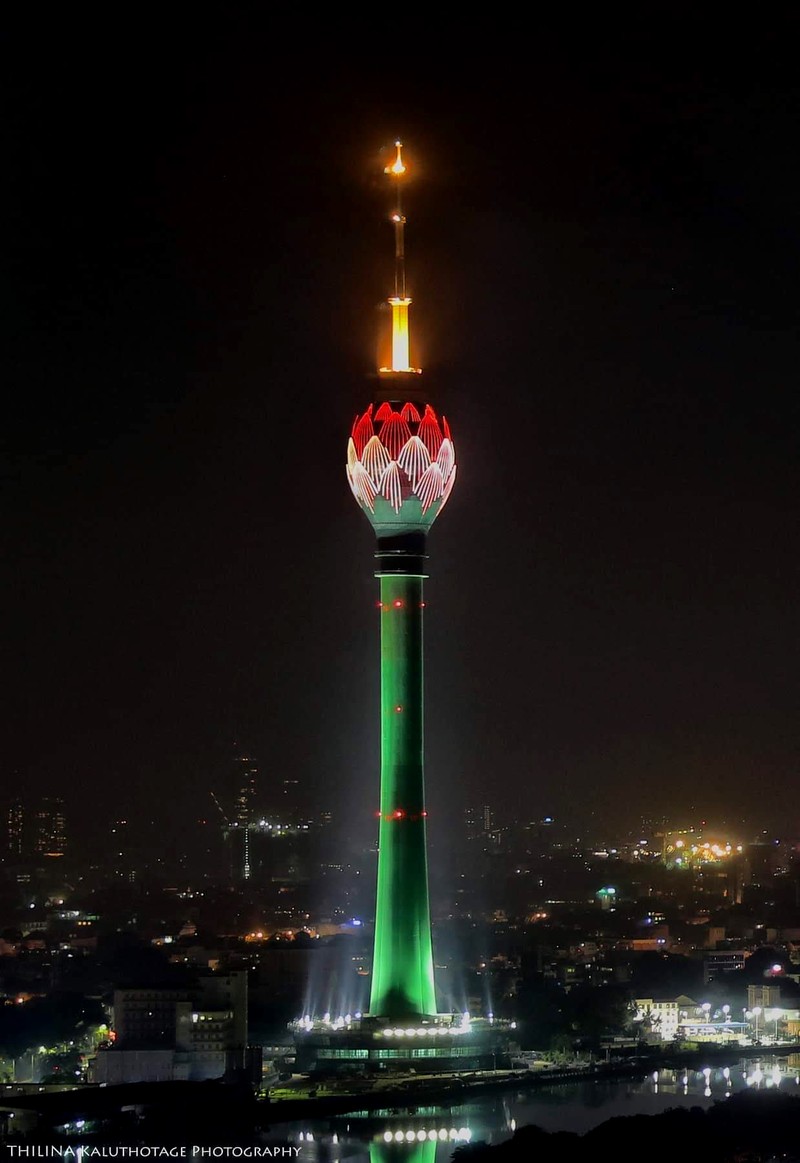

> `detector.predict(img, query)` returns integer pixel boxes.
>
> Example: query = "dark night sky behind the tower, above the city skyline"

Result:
[1,22,800,840]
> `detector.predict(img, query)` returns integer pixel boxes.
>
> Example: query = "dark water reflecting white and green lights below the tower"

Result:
[267,1056,800,1163]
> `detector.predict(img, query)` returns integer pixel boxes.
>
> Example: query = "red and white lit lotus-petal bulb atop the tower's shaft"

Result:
[347,404,456,533]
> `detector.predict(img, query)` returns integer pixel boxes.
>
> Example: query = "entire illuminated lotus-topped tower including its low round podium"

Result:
[294,142,507,1071]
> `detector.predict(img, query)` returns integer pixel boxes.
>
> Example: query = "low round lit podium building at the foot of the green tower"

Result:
[292,1014,519,1077]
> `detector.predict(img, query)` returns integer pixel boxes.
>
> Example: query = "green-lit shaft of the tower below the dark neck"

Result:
[370,572,436,1020]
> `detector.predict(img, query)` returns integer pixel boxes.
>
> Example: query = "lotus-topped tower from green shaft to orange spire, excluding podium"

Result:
[347,142,456,1021]
